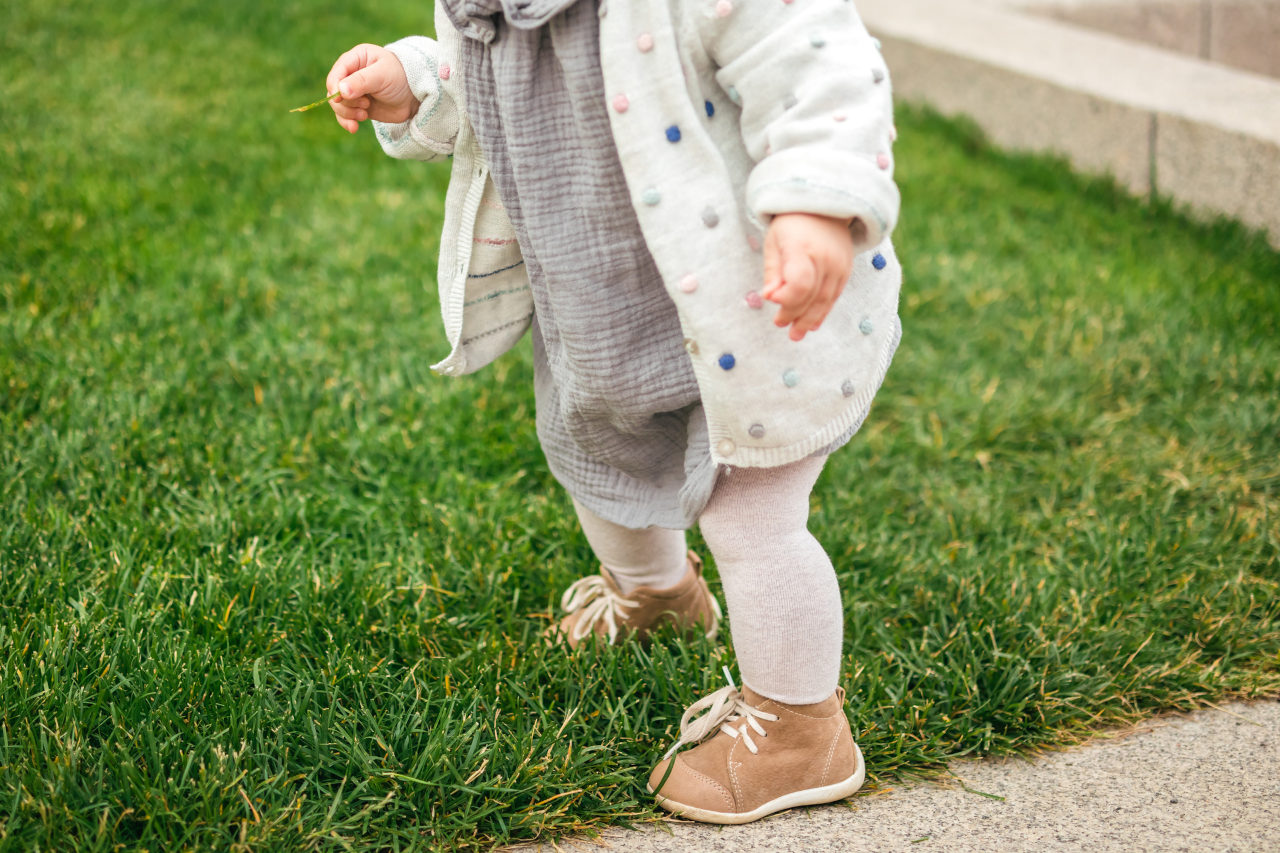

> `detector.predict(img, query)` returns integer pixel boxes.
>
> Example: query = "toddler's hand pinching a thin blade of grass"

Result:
[325,45,419,133]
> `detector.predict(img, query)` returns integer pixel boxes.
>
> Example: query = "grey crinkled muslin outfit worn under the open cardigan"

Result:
[444,0,732,528]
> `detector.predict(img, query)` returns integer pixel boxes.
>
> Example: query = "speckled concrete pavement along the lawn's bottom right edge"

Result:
[513,701,1280,853]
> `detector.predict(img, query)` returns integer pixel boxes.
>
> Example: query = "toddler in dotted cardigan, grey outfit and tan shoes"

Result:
[326,0,901,824]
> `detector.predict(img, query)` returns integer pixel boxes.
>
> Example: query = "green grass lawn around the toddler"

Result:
[0,0,1280,850]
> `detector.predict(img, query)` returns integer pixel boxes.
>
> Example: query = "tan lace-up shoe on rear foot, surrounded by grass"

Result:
[549,551,721,648]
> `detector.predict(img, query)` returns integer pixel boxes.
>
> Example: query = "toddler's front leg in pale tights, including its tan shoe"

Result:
[649,459,865,824]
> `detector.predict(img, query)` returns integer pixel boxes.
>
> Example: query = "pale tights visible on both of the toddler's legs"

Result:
[575,457,844,704]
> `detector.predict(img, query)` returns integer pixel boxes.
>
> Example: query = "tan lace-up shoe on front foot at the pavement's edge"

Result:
[649,681,867,824]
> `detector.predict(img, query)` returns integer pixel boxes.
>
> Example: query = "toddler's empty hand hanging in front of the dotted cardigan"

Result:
[760,214,854,341]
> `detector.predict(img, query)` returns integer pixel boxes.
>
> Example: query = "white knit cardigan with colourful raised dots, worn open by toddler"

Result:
[378,0,901,466]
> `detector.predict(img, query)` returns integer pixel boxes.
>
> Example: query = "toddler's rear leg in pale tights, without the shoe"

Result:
[573,501,689,593]
